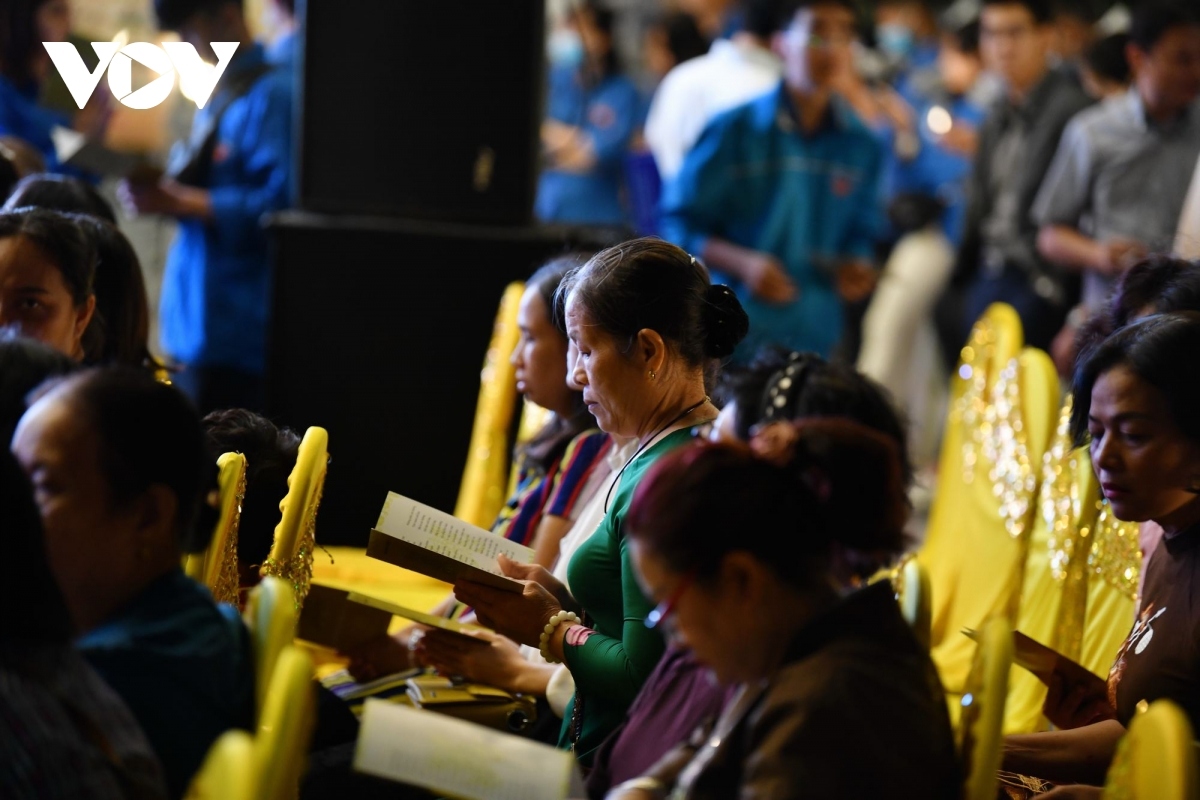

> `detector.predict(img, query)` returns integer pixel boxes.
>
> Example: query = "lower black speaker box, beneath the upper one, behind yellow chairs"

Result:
[266,211,628,547]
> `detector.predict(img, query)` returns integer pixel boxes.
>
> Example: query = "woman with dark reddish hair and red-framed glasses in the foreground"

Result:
[607,419,961,800]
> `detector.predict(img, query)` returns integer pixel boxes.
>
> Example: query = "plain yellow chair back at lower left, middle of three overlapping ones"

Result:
[254,645,316,800]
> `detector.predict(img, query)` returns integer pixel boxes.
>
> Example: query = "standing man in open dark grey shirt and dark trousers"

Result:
[940,0,1092,354]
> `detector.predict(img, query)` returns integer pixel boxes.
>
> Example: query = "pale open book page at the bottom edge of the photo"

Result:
[354,699,584,800]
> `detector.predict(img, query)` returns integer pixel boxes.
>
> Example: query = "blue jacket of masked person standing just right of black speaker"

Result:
[535,67,642,224]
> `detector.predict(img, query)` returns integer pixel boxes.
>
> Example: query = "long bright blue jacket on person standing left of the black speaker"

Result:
[158,44,293,374]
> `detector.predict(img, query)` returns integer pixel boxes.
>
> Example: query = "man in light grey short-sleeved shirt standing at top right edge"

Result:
[1033,5,1200,314]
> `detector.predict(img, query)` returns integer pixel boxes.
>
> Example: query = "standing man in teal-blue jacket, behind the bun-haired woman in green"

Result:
[664,0,883,361]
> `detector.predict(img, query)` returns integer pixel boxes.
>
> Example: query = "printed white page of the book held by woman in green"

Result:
[376,492,533,575]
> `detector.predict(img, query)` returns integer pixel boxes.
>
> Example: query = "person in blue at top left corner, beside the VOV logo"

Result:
[0,0,110,175]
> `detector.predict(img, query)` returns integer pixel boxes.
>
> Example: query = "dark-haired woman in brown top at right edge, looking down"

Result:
[1003,312,1200,798]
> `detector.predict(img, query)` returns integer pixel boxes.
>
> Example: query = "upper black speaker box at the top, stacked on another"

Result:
[296,0,545,224]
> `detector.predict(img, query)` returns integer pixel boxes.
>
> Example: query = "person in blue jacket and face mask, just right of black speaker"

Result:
[535,0,643,224]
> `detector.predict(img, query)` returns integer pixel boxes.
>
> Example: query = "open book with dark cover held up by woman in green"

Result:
[367,492,533,593]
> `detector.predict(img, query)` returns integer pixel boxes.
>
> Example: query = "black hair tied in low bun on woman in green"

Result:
[558,237,750,367]
